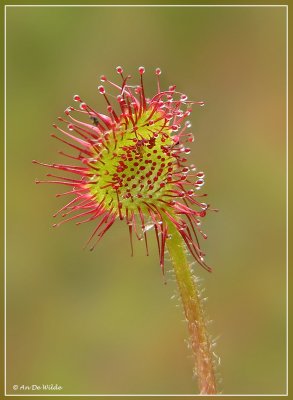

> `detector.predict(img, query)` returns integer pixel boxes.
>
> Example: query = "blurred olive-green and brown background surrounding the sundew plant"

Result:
[7,7,286,394]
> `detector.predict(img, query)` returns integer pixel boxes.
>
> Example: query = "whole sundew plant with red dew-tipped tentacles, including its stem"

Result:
[34,66,216,394]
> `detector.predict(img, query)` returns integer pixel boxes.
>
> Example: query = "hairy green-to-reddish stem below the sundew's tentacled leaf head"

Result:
[166,220,216,394]
